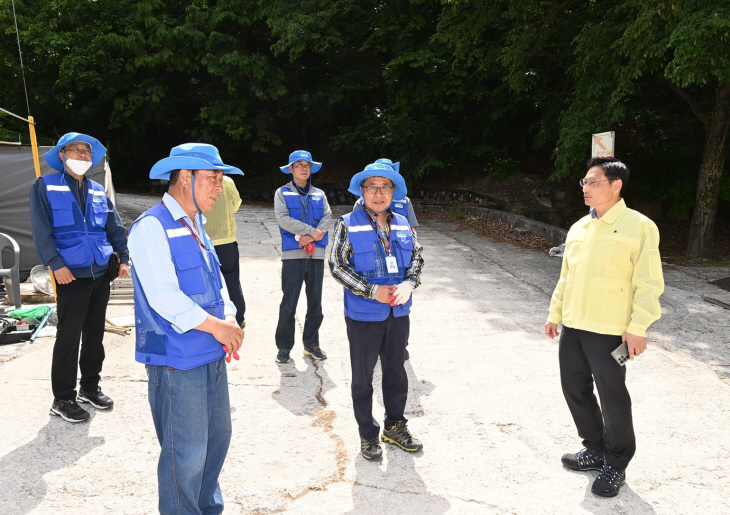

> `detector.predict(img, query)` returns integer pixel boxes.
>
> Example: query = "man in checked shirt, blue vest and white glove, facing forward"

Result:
[329,163,423,459]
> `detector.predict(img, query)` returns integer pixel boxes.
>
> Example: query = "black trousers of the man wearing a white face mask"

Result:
[51,271,109,400]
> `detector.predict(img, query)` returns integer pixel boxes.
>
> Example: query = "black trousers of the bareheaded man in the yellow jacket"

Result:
[559,327,636,472]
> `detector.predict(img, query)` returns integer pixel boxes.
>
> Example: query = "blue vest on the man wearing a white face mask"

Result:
[43,173,114,268]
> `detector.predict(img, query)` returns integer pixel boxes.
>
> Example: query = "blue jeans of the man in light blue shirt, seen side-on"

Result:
[146,358,231,515]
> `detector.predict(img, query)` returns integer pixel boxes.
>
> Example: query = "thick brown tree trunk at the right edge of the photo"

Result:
[687,83,730,258]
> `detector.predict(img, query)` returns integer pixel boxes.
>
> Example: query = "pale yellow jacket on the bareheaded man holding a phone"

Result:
[548,199,664,336]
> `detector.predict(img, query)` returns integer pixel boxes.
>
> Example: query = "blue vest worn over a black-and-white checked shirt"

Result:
[342,210,413,322]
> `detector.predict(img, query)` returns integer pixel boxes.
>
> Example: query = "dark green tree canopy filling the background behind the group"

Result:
[0,0,730,255]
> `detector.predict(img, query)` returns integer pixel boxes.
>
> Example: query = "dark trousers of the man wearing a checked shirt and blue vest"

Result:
[345,309,410,440]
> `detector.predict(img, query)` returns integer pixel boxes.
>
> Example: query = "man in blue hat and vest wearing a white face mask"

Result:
[30,132,129,422]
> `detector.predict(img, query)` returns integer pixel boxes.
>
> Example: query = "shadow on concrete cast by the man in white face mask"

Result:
[0,418,104,515]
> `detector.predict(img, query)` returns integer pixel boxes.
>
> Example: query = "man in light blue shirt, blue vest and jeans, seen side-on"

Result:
[129,143,243,515]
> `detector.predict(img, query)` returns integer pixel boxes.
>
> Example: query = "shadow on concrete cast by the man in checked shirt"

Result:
[347,444,451,515]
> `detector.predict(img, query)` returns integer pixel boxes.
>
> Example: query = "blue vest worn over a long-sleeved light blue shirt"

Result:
[130,204,225,370]
